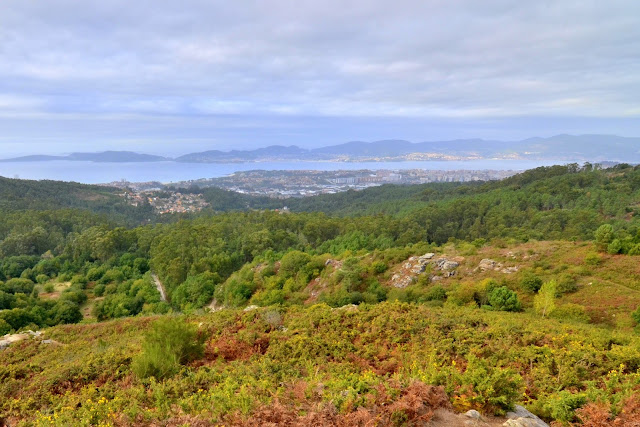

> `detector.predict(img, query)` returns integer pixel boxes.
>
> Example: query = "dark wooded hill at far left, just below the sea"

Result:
[0,177,153,222]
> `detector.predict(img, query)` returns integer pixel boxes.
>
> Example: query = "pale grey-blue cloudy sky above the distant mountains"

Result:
[0,0,640,157]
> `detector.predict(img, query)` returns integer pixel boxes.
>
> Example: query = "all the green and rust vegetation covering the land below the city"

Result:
[0,164,640,426]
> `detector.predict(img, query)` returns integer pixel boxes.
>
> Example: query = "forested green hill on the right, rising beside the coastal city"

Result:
[284,165,640,226]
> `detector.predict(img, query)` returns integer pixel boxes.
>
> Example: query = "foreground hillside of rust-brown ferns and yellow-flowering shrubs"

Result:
[0,303,640,426]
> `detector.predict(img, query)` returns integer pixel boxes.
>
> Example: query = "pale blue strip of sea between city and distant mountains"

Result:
[0,159,570,184]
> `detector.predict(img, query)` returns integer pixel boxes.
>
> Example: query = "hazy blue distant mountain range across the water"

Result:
[0,135,640,163]
